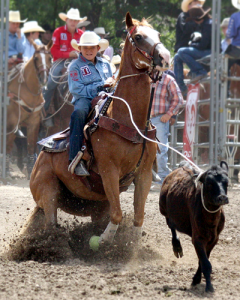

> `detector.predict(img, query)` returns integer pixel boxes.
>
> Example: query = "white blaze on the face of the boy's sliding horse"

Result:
[139,26,171,64]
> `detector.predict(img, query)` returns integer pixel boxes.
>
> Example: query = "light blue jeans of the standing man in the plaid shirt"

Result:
[151,114,171,182]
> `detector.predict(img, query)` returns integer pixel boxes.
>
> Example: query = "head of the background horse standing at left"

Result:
[32,41,52,85]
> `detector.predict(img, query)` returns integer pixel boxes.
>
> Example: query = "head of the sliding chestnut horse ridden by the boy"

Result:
[126,12,170,69]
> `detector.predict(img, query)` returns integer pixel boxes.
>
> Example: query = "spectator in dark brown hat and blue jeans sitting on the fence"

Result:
[174,7,212,97]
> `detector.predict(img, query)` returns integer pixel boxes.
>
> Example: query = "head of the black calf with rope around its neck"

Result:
[199,161,229,206]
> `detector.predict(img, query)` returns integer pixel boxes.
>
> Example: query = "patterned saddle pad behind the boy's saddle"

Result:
[37,133,69,152]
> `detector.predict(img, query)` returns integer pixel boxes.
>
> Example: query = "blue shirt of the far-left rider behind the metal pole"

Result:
[0,32,25,60]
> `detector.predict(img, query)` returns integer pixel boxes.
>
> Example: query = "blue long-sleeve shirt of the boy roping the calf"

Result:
[68,54,112,103]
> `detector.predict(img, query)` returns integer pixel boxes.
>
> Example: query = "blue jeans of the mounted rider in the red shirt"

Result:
[42,60,65,111]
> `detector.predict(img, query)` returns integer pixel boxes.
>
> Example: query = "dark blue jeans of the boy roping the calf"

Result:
[69,99,91,160]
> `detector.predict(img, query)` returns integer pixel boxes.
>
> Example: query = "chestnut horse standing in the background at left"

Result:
[7,42,52,177]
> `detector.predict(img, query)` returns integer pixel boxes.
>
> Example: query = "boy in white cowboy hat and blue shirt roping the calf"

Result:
[68,31,114,176]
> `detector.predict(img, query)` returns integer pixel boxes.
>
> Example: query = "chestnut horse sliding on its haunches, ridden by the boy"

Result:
[24,13,170,245]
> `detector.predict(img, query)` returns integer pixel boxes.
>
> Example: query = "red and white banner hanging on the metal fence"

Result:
[183,83,199,161]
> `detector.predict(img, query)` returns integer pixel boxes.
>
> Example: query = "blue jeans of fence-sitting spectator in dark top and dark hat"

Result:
[174,47,211,92]
